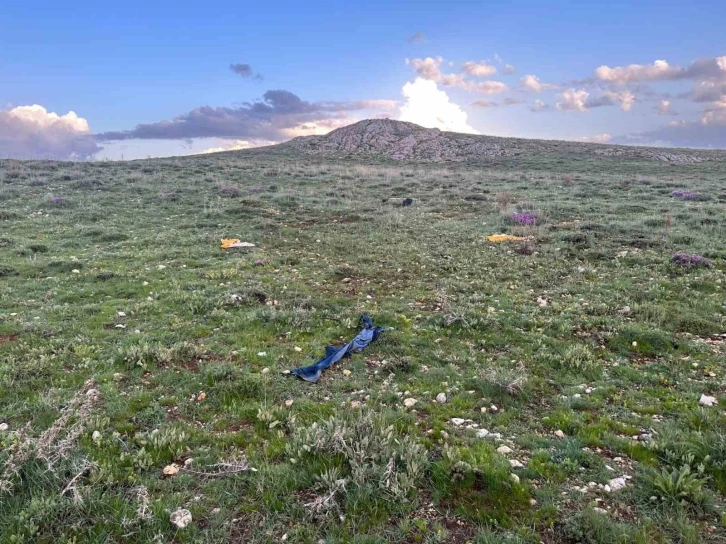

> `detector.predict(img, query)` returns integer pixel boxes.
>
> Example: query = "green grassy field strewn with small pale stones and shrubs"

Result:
[0,151,726,544]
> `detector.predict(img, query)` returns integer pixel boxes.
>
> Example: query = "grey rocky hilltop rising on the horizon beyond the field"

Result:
[280,119,726,164]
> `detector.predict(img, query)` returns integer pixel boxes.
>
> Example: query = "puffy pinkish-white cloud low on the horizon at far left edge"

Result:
[0,104,101,160]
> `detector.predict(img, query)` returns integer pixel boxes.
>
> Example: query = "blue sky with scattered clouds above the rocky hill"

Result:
[0,0,726,160]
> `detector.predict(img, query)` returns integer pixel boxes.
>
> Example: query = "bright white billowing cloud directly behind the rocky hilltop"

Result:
[398,77,479,134]
